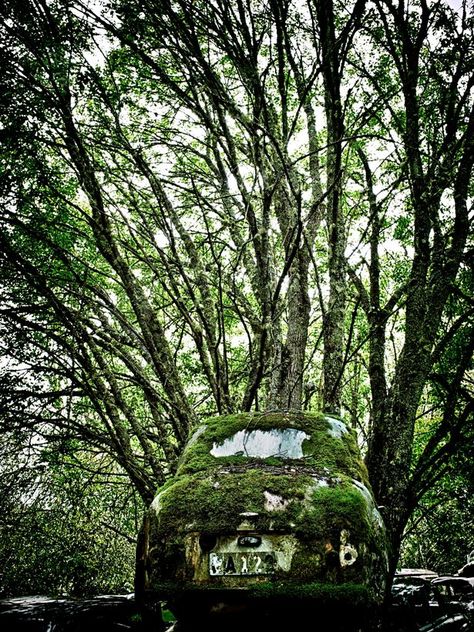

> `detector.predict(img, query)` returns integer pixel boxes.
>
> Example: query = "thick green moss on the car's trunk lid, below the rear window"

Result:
[152,468,374,556]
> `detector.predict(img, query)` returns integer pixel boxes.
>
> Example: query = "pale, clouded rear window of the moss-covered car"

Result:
[211,428,309,459]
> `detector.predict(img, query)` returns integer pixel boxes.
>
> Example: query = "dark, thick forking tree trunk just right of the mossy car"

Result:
[356,0,474,572]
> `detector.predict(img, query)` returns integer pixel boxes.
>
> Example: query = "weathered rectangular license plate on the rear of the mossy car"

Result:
[209,551,277,576]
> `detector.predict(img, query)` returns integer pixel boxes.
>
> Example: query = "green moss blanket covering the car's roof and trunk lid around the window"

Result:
[148,413,378,535]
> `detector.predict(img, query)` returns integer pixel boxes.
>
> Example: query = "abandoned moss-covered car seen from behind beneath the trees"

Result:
[136,413,387,619]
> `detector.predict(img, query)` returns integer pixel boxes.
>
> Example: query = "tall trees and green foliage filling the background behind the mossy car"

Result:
[0,0,474,592]
